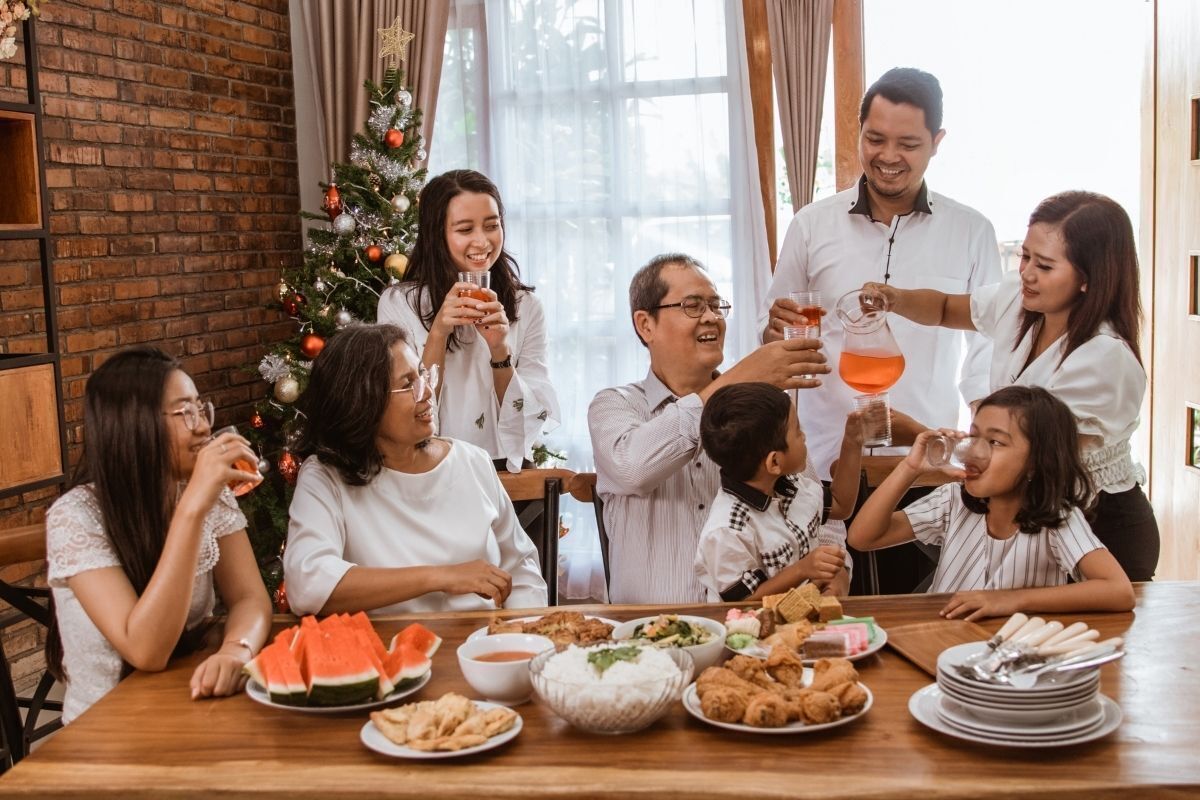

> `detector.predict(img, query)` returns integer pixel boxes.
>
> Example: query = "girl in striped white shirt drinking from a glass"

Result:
[848,386,1134,620]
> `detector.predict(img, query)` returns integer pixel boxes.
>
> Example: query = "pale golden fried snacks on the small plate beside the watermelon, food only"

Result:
[371,692,517,751]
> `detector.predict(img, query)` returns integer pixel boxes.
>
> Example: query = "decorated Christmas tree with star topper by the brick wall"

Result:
[241,20,426,595]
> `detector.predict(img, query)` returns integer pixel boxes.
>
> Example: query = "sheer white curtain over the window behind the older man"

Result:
[430,0,769,599]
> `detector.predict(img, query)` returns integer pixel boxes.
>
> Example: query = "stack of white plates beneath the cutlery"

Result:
[908,642,1121,747]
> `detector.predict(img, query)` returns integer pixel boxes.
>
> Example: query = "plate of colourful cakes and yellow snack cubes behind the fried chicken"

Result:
[725,584,888,663]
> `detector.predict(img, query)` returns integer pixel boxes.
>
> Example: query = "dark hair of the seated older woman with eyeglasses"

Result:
[296,325,408,486]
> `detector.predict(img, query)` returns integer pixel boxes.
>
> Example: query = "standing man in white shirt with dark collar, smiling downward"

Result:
[760,67,1001,590]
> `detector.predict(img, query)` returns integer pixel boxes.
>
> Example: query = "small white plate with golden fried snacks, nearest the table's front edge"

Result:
[359,692,523,758]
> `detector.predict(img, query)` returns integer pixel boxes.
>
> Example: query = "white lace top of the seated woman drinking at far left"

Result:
[46,483,246,724]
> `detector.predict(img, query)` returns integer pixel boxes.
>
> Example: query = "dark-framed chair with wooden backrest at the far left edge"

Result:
[0,524,62,771]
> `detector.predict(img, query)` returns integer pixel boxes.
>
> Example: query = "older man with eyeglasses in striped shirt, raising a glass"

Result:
[588,253,844,603]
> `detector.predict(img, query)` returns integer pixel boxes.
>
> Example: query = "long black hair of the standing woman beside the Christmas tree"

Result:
[401,169,533,351]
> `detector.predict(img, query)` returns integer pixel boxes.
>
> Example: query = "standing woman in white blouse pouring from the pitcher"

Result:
[864,192,1159,581]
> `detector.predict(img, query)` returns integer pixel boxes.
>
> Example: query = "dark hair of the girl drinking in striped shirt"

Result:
[962,386,1092,534]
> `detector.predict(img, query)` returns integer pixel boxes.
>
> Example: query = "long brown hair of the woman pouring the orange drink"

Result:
[1013,192,1141,363]
